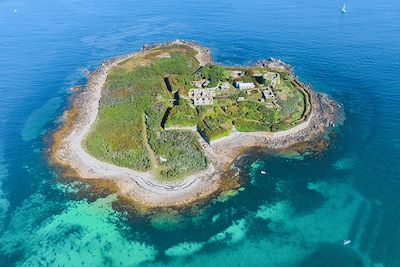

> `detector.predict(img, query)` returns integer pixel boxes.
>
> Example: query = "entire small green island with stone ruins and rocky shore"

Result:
[50,40,339,207]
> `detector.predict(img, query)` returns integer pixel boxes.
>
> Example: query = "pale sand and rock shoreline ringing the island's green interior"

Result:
[51,40,338,207]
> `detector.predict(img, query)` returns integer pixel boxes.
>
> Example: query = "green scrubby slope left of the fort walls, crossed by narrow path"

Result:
[84,45,207,180]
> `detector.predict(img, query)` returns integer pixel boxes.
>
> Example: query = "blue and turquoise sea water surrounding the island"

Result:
[0,0,400,266]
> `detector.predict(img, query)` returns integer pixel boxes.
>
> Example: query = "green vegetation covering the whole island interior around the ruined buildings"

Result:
[84,45,310,181]
